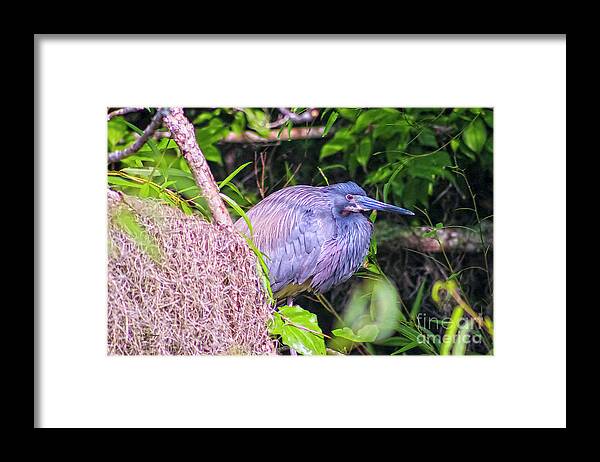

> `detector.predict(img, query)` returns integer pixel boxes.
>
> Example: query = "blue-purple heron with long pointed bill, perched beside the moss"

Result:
[235,181,414,305]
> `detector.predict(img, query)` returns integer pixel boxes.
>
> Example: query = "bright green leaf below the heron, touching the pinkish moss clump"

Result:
[271,306,326,355]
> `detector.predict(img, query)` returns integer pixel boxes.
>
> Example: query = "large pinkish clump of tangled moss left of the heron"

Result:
[107,191,275,355]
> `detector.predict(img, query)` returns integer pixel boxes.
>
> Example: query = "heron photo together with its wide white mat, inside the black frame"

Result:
[34,35,566,427]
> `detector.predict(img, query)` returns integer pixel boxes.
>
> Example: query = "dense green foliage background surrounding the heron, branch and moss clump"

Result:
[108,108,493,355]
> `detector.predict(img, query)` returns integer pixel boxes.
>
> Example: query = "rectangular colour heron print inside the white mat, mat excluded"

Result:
[107,107,494,356]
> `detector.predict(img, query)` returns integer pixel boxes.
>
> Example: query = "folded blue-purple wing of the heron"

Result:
[236,186,335,292]
